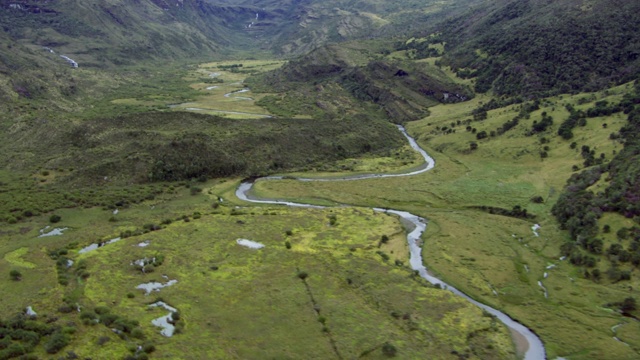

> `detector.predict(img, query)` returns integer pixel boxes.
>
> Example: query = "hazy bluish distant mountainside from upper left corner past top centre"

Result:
[0,0,479,67]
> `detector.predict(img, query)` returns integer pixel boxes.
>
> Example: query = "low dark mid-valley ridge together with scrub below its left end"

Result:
[0,108,402,223]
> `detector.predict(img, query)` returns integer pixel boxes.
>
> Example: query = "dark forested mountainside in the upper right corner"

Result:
[438,0,640,96]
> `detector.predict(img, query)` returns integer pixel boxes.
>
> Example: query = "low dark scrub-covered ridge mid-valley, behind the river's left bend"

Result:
[7,112,401,183]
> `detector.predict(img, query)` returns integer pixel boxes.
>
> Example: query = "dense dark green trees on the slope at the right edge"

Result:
[553,82,640,282]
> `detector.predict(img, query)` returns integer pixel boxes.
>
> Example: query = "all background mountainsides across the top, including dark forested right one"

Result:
[0,0,640,103]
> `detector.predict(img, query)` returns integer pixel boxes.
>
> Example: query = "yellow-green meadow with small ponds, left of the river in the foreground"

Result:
[0,181,513,359]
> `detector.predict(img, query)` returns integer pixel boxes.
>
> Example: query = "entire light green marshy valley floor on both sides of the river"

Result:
[0,59,640,359]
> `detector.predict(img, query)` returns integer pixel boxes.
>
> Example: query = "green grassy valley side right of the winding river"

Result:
[245,85,640,358]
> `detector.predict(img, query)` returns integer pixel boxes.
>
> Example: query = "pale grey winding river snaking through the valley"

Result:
[236,125,546,360]
